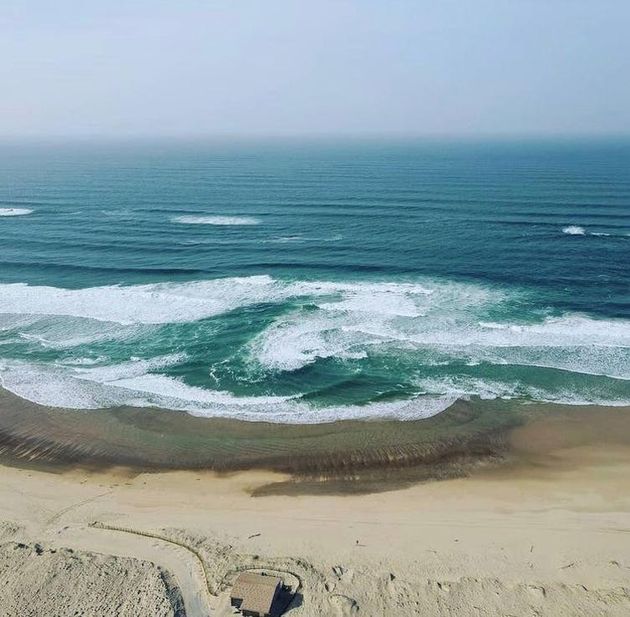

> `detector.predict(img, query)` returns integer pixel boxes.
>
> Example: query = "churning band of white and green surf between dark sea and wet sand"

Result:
[0,275,630,422]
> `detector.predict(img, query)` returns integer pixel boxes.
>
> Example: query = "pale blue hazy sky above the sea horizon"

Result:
[0,0,630,136]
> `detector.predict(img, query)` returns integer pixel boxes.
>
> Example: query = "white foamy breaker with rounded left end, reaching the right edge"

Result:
[251,313,630,379]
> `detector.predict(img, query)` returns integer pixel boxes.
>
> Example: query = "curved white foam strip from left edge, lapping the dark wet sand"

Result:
[0,361,455,424]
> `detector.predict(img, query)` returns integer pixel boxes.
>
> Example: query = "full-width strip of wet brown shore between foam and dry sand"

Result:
[0,390,630,495]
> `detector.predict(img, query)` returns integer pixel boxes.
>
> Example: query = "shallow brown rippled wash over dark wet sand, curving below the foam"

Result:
[0,390,534,480]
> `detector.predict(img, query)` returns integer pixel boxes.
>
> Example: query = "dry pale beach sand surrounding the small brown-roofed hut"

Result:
[0,416,630,617]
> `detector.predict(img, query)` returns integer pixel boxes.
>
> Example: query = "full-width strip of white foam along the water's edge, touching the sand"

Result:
[0,361,629,424]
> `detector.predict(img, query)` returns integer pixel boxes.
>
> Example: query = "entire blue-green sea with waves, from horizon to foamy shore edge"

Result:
[0,141,630,422]
